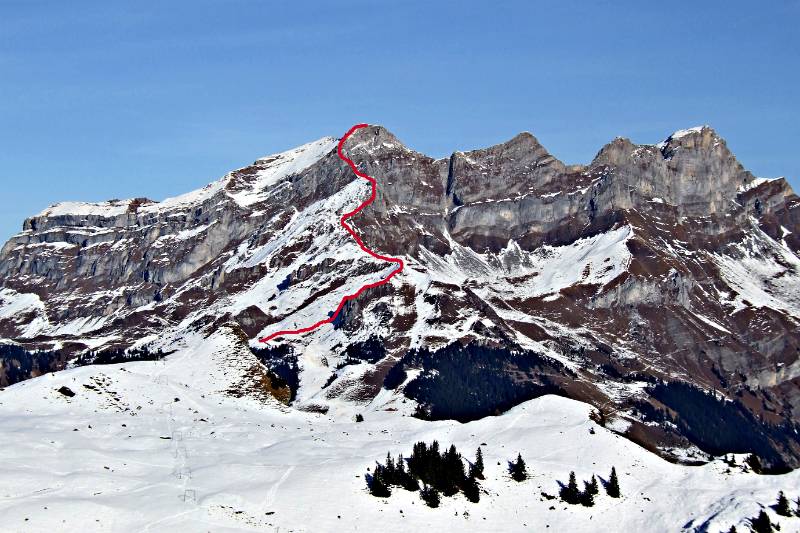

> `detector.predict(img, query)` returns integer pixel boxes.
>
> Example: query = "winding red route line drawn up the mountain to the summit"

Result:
[258,124,405,342]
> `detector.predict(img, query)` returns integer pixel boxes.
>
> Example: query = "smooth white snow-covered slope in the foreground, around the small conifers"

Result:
[0,327,800,532]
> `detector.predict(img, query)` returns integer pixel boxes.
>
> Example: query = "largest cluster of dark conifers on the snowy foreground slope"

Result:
[369,441,484,507]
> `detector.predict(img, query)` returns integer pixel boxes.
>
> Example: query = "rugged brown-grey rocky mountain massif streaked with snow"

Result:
[0,126,800,466]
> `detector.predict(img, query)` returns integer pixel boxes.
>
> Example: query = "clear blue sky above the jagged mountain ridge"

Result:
[0,0,800,241]
